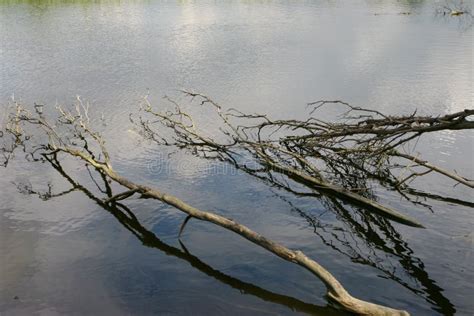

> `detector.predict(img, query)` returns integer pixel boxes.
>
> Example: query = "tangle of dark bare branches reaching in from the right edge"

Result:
[132,91,474,227]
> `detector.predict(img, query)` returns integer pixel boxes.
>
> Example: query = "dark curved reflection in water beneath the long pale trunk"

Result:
[22,156,349,316]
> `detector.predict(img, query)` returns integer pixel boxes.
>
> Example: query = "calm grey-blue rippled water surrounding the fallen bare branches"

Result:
[0,0,474,315]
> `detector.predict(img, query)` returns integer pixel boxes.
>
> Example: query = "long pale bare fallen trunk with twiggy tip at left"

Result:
[0,100,408,315]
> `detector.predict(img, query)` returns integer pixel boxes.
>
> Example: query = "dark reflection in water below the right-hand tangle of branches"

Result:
[226,164,460,315]
